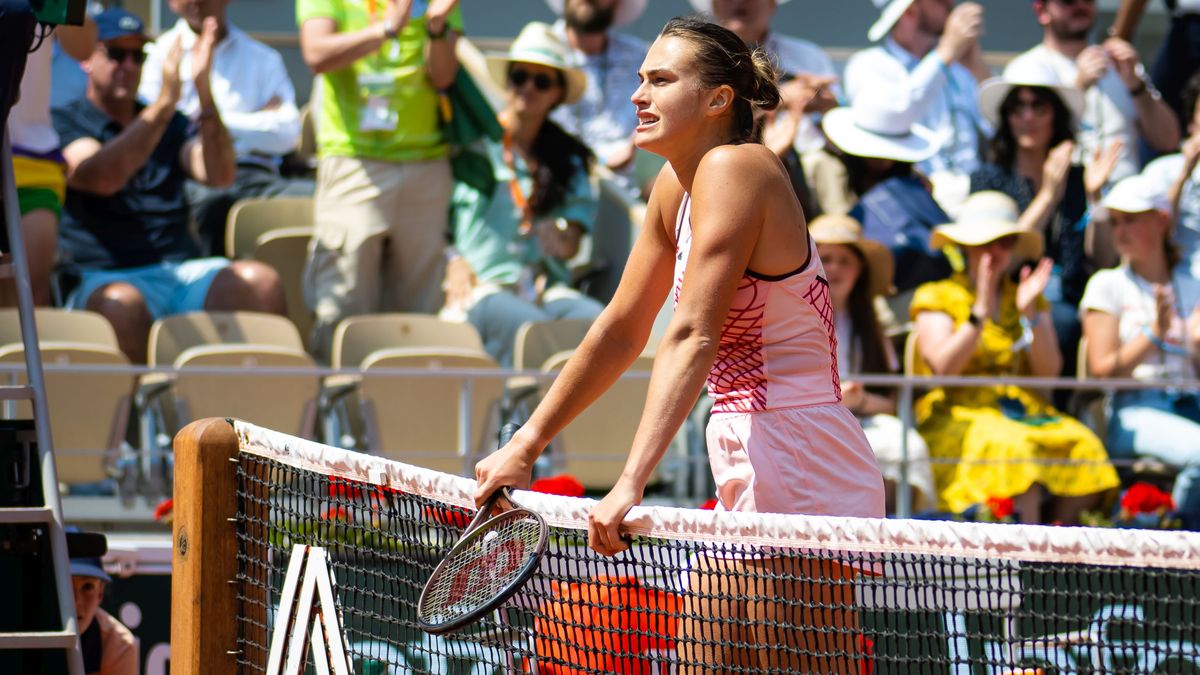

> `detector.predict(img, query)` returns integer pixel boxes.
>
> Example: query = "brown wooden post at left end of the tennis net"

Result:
[170,418,239,675]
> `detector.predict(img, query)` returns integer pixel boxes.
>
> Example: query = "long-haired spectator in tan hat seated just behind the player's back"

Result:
[809,215,937,513]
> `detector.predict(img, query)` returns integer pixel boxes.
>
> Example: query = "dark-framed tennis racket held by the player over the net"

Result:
[416,424,550,634]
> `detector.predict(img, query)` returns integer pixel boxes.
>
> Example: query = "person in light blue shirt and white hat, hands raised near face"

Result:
[845,0,991,207]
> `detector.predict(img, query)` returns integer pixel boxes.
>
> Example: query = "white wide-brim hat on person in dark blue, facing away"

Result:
[821,104,942,163]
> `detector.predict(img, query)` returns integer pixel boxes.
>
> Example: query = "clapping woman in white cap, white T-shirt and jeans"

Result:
[1080,175,1200,530]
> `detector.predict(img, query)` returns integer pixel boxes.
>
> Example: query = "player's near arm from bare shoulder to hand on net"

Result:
[588,147,774,555]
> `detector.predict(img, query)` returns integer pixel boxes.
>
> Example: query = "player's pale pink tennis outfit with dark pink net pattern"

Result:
[674,195,884,518]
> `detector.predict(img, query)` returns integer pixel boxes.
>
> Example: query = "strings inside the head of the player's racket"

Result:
[420,512,545,623]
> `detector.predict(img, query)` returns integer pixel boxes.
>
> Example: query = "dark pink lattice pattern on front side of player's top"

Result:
[708,275,767,412]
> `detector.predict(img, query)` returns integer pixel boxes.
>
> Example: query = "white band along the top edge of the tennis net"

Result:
[233,420,1200,569]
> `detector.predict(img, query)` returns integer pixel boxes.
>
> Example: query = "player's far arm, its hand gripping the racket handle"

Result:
[475,165,682,504]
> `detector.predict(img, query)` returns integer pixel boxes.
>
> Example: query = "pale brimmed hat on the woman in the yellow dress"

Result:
[929,190,1043,261]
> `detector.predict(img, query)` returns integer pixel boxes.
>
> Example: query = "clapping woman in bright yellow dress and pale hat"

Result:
[911,192,1118,525]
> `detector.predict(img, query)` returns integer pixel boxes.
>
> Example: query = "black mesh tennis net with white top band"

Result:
[225,423,1200,675]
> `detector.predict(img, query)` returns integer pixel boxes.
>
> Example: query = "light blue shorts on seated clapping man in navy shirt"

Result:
[67,258,229,319]
